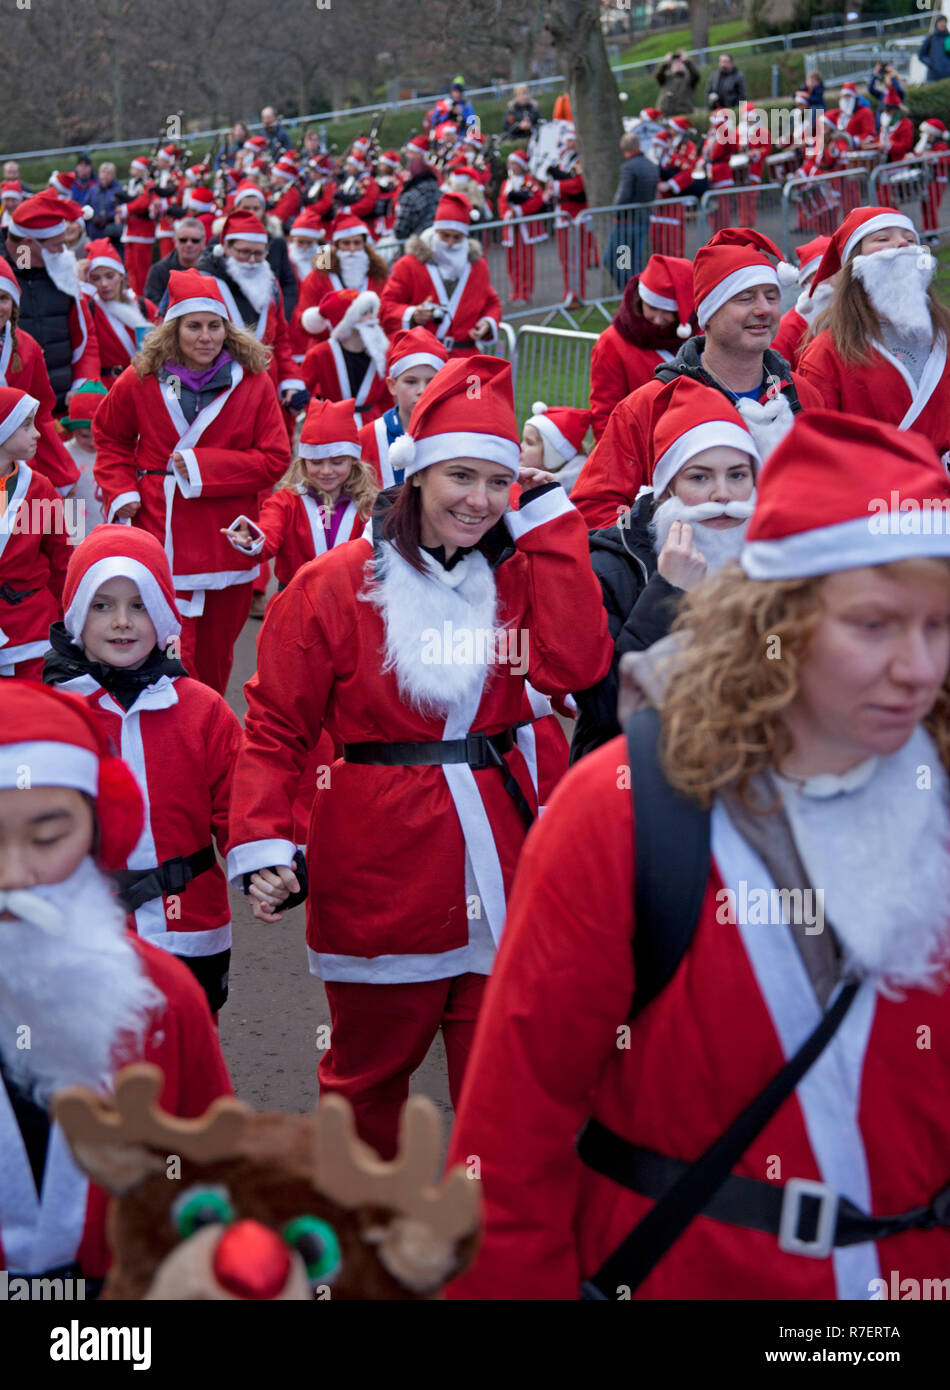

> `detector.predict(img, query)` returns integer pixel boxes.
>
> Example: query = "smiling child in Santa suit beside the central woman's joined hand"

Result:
[43,525,241,1013]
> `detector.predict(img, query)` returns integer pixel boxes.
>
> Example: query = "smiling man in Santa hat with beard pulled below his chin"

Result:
[570,227,821,528]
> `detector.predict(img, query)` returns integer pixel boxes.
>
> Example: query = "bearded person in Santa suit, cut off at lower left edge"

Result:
[0,681,231,1298]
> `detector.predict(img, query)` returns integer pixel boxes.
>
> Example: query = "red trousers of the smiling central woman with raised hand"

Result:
[317,974,488,1159]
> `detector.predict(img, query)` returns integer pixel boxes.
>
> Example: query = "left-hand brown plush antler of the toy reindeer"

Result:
[53,1062,250,1163]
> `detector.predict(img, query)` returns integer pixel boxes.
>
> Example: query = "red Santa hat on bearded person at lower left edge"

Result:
[0,681,145,870]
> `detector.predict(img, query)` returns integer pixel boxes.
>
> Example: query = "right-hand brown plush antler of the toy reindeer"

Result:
[316,1095,478,1240]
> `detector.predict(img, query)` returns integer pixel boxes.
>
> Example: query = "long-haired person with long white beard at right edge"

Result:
[800,207,950,456]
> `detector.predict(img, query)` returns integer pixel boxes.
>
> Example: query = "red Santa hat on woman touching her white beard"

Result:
[651,377,761,498]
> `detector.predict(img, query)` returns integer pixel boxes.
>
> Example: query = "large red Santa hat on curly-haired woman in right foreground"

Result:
[741,410,950,580]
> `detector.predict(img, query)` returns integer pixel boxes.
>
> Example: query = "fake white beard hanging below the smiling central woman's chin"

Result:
[360,542,498,716]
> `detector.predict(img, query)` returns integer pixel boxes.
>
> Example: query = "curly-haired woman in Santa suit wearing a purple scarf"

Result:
[93,270,291,694]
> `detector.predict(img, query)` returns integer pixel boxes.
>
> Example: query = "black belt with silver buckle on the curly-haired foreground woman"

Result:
[577,1119,950,1259]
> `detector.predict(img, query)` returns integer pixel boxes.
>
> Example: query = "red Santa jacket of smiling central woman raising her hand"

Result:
[228,487,611,983]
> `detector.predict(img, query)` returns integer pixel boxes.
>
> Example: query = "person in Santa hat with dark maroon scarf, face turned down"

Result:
[590,254,698,439]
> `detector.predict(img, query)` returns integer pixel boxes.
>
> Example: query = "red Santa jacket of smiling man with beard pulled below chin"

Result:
[570,355,822,530]
